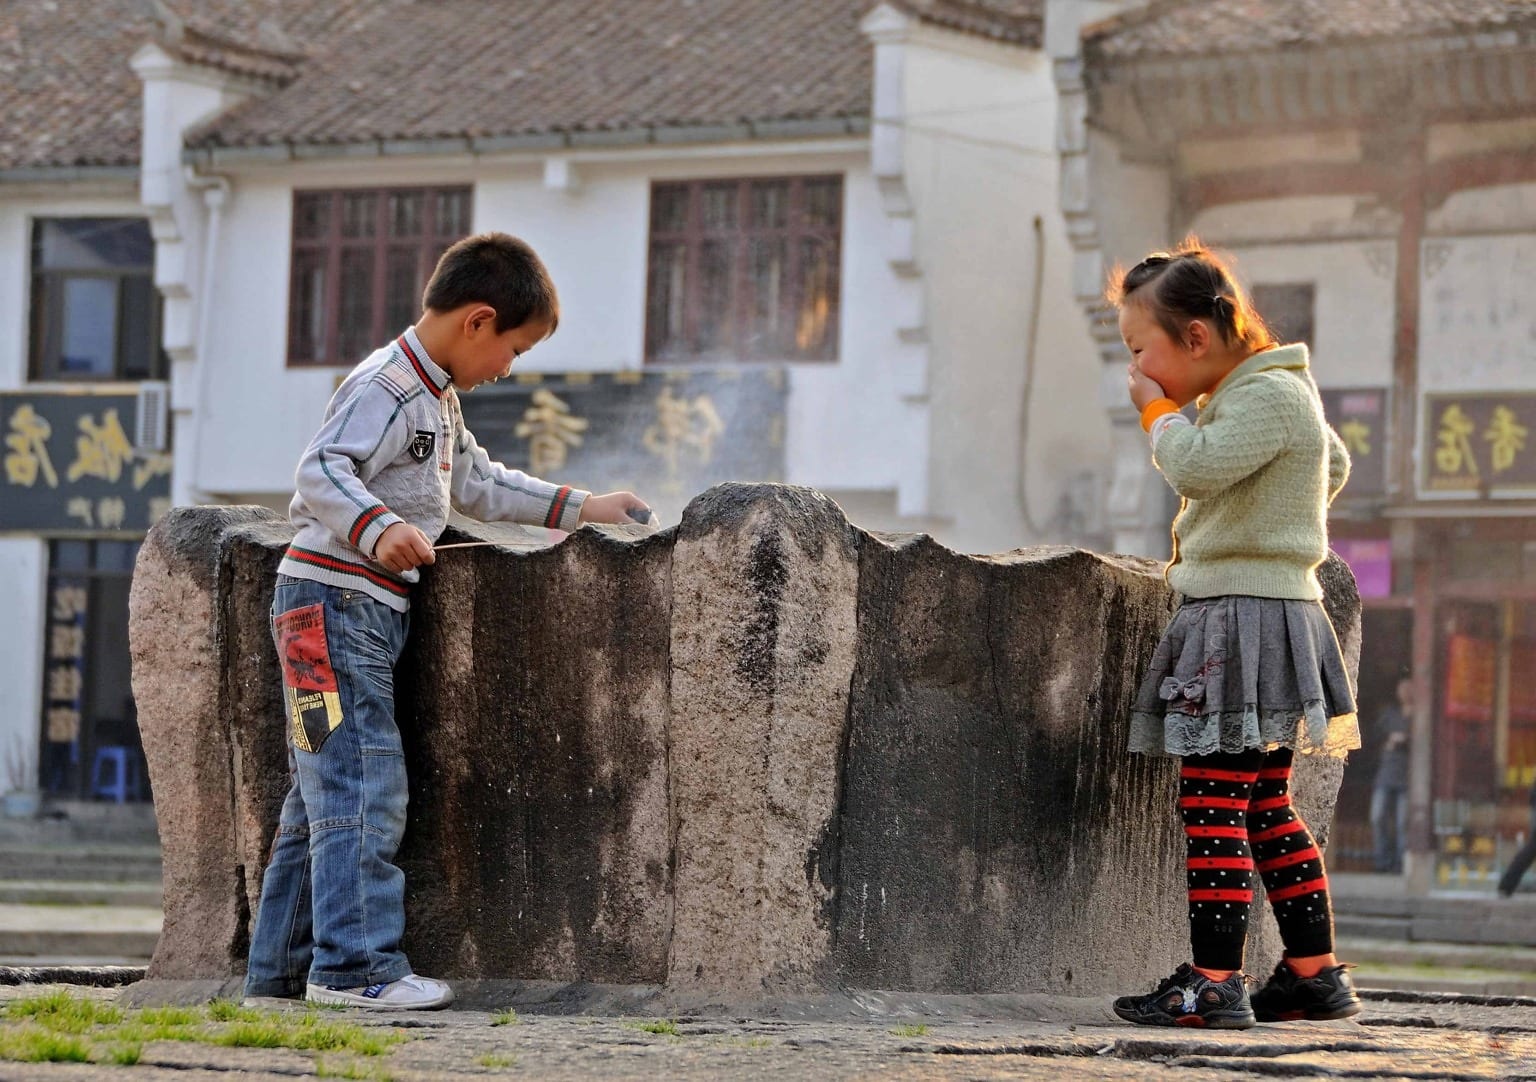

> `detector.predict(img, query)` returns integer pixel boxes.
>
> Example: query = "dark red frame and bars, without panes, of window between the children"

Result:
[645,174,848,364]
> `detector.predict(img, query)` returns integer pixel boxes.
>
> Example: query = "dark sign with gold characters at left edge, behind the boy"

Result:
[0,392,170,533]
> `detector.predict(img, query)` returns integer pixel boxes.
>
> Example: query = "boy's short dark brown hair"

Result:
[421,234,561,334]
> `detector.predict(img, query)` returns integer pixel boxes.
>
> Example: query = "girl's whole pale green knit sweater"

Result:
[1152,344,1349,601]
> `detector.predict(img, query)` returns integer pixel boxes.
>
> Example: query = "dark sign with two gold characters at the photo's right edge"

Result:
[1419,390,1536,498]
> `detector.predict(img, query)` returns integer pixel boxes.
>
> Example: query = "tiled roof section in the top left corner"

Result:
[0,0,154,169]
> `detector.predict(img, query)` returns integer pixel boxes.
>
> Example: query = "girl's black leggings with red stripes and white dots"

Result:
[1178,747,1333,970]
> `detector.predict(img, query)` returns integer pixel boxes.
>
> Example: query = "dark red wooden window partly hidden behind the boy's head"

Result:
[289,188,470,364]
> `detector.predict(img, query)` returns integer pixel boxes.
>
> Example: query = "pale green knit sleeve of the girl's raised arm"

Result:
[1152,378,1303,500]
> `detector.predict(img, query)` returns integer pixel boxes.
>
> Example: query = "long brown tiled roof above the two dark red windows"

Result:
[187,0,890,148]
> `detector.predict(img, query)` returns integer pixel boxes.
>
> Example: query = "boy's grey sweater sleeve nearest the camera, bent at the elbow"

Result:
[295,380,410,556]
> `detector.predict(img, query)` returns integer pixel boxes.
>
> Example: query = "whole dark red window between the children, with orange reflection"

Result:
[645,177,843,363]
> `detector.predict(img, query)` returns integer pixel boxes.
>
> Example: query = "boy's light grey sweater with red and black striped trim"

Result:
[278,327,591,612]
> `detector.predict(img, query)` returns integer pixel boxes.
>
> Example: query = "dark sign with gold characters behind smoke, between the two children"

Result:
[459,366,788,510]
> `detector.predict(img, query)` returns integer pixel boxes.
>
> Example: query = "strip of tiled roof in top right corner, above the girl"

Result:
[1083,0,1536,61]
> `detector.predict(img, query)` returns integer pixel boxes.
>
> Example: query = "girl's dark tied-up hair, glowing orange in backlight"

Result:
[1104,234,1275,353]
